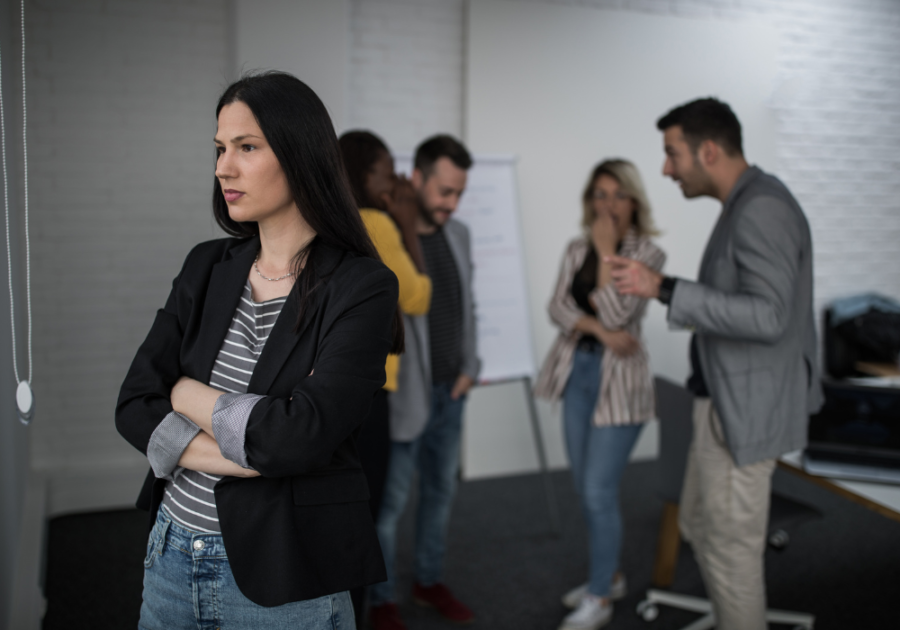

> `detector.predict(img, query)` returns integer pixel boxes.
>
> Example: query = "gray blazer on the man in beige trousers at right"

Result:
[668,167,822,466]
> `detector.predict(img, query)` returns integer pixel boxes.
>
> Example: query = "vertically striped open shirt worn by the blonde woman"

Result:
[534,229,666,426]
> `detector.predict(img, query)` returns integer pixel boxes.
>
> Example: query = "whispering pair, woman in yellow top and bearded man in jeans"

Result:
[340,131,481,629]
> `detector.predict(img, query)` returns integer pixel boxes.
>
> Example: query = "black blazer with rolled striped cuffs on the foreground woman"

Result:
[116,238,398,606]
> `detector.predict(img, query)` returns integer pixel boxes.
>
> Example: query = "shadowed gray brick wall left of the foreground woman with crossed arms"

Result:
[27,0,227,482]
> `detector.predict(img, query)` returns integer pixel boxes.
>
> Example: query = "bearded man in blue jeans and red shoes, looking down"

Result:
[370,135,481,630]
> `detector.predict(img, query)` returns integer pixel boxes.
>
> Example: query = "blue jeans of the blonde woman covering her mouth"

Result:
[563,346,643,597]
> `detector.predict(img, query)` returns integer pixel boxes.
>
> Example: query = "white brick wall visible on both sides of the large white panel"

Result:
[349,0,900,316]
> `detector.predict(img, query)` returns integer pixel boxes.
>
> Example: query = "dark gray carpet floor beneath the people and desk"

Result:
[44,463,900,630]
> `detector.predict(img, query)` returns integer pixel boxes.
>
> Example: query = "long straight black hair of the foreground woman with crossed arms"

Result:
[213,72,404,354]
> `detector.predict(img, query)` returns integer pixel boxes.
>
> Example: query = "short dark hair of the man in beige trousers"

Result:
[656,98,744,155]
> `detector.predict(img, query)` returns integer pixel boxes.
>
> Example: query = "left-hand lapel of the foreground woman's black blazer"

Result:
[198,237,259,383]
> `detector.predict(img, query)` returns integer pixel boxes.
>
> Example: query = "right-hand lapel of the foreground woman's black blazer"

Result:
[247,242,343,394]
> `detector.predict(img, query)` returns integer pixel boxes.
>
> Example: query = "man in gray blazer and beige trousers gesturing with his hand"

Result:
[604,98,822,630]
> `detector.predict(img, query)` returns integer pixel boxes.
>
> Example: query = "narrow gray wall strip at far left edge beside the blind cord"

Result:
[0,0,29,628]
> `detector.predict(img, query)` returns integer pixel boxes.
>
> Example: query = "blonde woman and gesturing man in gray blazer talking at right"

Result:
[535,98,822,630]
